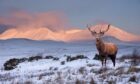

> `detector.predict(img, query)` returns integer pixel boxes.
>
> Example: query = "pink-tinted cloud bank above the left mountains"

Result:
[0,11,68,31]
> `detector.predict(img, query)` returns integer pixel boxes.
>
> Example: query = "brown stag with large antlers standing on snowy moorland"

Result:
[87,24,118,67]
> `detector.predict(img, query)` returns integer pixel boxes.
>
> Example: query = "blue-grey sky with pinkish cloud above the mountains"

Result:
[0,0,140,35]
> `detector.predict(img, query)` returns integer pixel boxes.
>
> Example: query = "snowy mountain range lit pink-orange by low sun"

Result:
[0,25,140,42]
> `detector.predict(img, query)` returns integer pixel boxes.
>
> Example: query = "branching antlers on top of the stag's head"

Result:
[87,24,110,35]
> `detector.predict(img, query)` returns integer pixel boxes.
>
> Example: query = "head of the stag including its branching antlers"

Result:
[87,24,110,39]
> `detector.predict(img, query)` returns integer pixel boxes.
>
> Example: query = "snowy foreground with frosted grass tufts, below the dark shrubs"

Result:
[0,52,140,84]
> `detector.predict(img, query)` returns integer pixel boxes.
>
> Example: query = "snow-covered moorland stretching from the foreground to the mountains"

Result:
[0,40,140,84]
